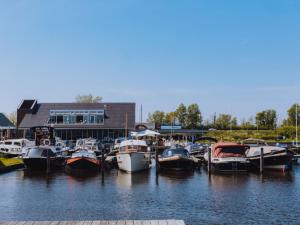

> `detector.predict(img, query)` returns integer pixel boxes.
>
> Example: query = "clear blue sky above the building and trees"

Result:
[0,0,300,123]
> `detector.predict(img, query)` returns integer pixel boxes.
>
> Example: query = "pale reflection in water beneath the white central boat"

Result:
[116,170,151,188]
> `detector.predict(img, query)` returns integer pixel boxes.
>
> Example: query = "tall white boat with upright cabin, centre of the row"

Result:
[117,139,151,173]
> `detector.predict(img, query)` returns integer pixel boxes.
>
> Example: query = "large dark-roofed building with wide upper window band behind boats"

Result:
[17,100,135,142]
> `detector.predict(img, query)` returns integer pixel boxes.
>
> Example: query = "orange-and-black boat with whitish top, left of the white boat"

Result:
[66,149,100,172]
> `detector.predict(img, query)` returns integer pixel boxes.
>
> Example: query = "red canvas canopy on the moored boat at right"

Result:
[212,142,249,158]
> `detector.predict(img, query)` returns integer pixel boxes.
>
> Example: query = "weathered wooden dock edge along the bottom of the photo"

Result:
[0,220,185,225]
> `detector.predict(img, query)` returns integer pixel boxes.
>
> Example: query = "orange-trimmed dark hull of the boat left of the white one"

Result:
[66,157,100,172]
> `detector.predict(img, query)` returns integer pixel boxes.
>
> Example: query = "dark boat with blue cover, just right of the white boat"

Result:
[158,147,194,171]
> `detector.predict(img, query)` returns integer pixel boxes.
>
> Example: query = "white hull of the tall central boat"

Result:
[117,152,151,173]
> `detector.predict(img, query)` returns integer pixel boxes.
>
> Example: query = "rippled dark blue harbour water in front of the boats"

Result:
[0,163,300,225]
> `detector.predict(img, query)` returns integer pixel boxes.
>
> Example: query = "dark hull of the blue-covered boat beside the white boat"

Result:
[158,156,194,171]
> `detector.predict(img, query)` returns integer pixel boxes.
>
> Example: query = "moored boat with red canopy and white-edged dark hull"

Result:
[204,142,250,172]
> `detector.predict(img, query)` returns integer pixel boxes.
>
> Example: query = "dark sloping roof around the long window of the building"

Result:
[19,103,135,129]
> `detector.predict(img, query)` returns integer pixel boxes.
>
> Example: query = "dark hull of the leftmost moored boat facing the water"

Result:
[23,158,65,171]
